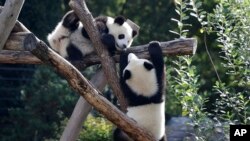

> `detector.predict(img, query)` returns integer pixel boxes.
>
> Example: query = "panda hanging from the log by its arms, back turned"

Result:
[113,42,166,141]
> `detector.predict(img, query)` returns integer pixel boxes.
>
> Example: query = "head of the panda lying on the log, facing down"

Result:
[107,16,139,50]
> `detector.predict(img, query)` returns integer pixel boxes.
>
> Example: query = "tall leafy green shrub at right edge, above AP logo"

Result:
[205,0,250,124]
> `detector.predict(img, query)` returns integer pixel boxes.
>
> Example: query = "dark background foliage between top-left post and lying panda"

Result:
[18,0,67,41]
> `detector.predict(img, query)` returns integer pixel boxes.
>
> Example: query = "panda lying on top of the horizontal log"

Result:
[47,11,139,60]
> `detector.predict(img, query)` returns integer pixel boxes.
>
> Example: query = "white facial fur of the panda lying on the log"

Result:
[107,17,133,50]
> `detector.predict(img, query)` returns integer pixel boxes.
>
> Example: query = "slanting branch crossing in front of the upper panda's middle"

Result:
[69,0,127,112]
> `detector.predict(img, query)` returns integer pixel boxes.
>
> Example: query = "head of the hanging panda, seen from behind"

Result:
[122,53,158,97]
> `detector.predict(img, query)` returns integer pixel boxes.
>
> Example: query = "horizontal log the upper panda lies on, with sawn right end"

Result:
[0,37,197,69]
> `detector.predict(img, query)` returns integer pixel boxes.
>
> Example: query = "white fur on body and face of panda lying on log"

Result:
[47,17,136,58]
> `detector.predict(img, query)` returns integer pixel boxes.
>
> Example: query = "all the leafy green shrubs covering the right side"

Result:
[170,0,250,140]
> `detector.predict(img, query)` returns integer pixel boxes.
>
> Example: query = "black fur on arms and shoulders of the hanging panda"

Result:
[120,42,165,106]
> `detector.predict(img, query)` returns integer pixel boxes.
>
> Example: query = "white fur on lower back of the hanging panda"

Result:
[127,102,165,140]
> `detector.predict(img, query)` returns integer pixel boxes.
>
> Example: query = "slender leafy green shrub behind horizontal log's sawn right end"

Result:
[169,0,205,118]
